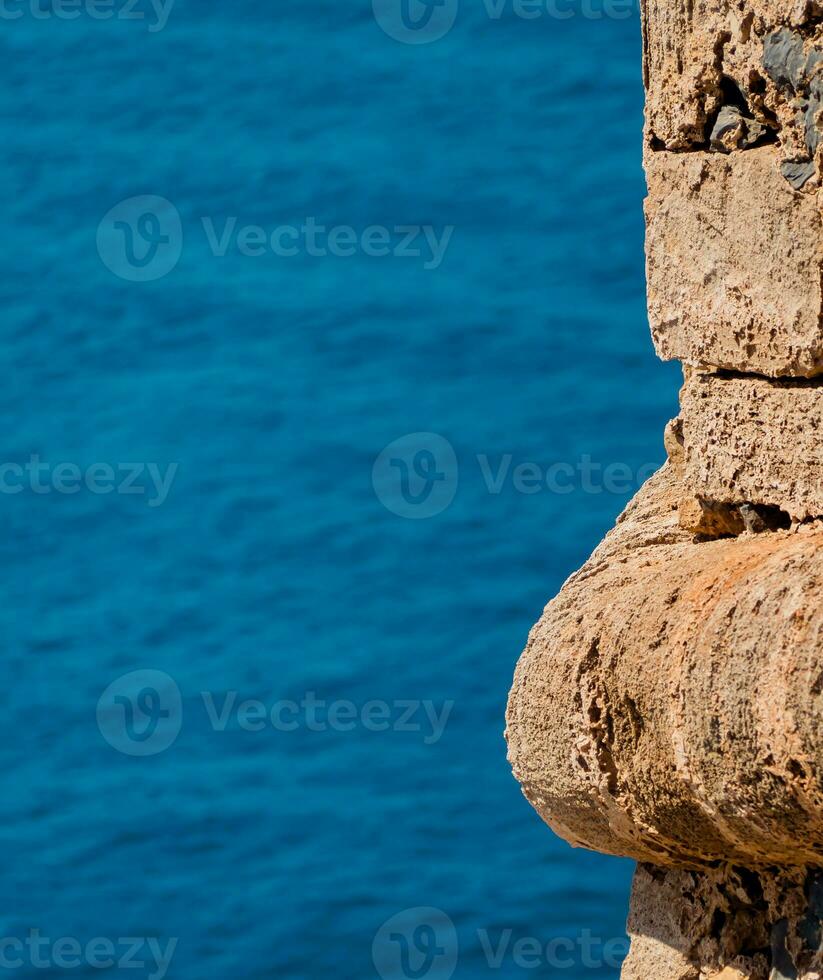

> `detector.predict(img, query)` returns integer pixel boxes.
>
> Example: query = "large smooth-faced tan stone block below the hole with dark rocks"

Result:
[646,147,823,377]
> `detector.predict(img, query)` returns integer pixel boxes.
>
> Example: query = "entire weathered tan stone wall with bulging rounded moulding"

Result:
[507,0,823,980]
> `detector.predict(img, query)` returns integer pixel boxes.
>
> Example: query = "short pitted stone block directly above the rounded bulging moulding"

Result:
[680,371,823,521]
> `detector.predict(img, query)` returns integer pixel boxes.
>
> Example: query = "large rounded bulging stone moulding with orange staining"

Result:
[507,465,823,866]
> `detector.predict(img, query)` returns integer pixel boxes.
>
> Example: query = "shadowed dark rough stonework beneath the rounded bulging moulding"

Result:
[622,864,823,980]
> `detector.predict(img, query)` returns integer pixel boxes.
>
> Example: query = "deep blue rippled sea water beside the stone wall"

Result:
[0,0,678,980]
